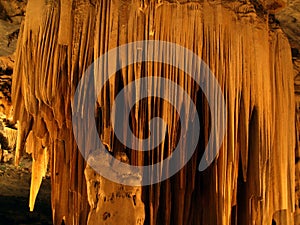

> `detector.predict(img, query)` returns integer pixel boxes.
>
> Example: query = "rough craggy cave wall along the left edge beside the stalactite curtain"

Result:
[0,0,26,166]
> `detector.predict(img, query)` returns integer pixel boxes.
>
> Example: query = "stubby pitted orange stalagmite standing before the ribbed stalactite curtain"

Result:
[85,156,145,225]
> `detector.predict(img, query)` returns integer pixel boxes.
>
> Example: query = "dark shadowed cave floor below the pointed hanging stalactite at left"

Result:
[0,156,52,225]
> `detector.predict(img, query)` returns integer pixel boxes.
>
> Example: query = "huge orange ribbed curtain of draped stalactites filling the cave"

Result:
[12,0,296,225]
